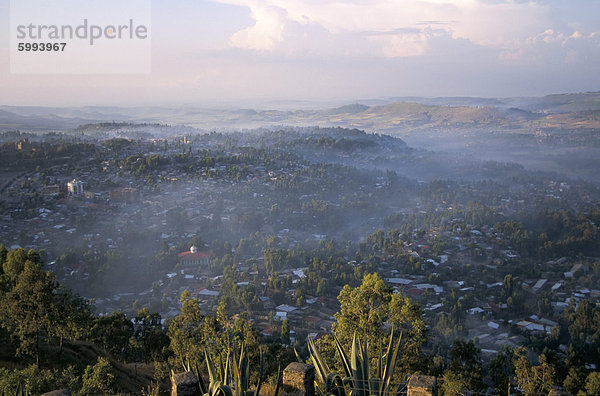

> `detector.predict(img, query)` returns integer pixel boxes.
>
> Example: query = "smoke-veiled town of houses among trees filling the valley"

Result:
[0,128,600,370]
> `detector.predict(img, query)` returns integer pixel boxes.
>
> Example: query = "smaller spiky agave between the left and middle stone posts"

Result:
[201,344,264,396]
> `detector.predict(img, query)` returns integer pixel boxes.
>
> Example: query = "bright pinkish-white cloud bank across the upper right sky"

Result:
[215,0,600,60]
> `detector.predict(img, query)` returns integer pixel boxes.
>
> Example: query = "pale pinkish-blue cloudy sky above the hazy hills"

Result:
[0,0,600,107]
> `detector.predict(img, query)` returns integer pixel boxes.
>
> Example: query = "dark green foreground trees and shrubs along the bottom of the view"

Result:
[0,246,600,395]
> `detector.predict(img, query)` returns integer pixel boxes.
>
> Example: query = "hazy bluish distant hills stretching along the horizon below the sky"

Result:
[0,92,600,133]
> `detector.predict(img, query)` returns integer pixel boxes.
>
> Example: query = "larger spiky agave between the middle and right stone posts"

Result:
[308,330,402,396]
